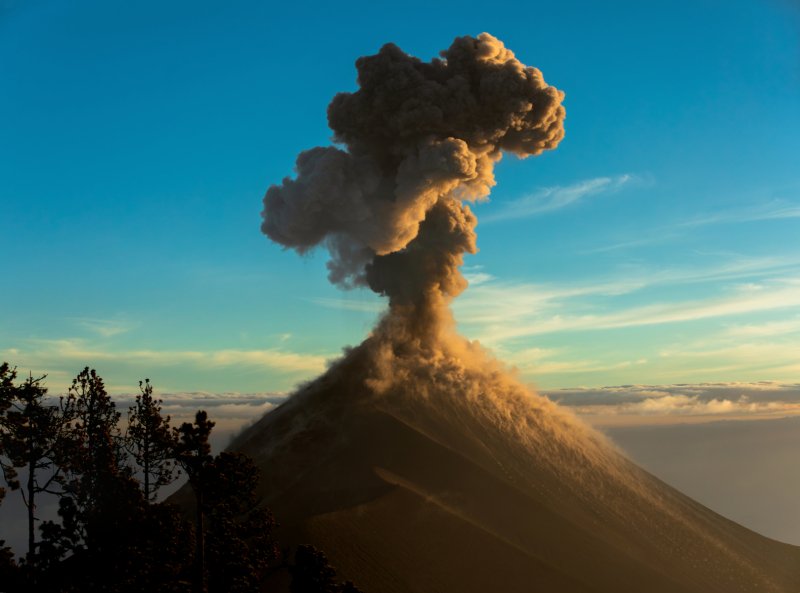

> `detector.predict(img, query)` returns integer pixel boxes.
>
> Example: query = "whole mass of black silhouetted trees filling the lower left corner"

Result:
[0,363,359,593]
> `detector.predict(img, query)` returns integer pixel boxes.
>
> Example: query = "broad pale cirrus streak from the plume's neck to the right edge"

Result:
[454,258,800,344]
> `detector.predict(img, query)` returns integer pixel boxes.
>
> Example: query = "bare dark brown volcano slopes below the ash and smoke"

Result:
[228,346,800,593]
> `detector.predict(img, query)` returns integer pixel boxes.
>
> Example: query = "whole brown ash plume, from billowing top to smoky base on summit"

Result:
[262,33,576,442]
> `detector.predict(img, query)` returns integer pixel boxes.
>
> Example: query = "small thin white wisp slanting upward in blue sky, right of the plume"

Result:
[480,174,639,224]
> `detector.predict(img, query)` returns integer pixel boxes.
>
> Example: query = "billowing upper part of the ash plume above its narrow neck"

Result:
[261,33,564,312]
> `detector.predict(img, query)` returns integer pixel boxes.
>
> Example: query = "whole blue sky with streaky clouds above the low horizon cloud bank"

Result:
[0,0,800,393]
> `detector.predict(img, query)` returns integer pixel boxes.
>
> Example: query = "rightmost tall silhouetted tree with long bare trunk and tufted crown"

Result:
[175,410,214,593]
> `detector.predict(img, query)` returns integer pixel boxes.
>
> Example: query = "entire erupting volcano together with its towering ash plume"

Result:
[239,33,800,593]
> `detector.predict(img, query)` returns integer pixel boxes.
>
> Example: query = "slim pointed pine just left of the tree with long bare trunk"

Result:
[125,379,176,503]
